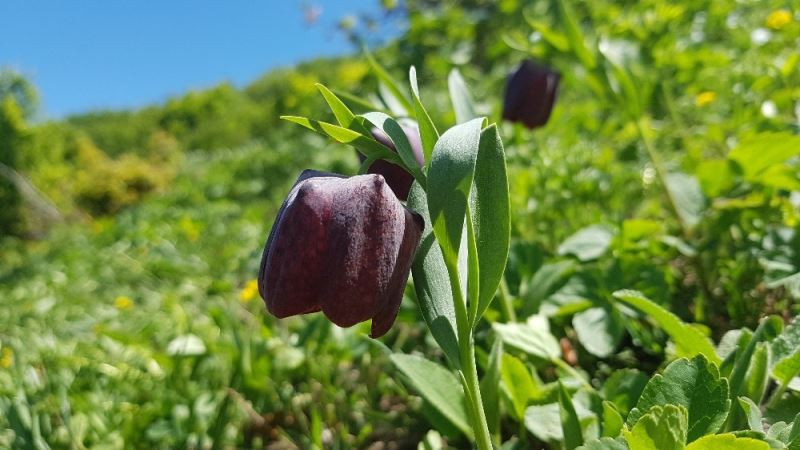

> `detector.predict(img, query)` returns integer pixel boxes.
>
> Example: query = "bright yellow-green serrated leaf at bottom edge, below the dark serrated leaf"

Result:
[623,404,689,450]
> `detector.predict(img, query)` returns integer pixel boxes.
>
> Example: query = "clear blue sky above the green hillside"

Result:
[0,0,396,118]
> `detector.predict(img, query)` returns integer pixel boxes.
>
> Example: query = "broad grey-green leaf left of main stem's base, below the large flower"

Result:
[391,353,472,436]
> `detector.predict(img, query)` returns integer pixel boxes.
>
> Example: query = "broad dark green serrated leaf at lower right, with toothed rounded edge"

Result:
[627,355,731,442]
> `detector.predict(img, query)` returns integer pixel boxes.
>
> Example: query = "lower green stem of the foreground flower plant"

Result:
[445,263,492,450]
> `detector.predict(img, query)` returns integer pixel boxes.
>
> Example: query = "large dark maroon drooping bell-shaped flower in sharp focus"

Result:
[258,170,424,337]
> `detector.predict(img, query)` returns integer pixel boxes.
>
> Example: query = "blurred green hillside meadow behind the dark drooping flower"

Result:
[0,0,800,449]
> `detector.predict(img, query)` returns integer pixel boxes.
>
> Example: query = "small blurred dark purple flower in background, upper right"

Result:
[503,60,561,129]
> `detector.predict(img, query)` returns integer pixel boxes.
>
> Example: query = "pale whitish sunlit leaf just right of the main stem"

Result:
[492,316,561,361]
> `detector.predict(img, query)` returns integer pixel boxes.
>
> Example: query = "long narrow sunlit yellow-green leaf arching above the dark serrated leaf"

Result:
[613,289,721,364]
